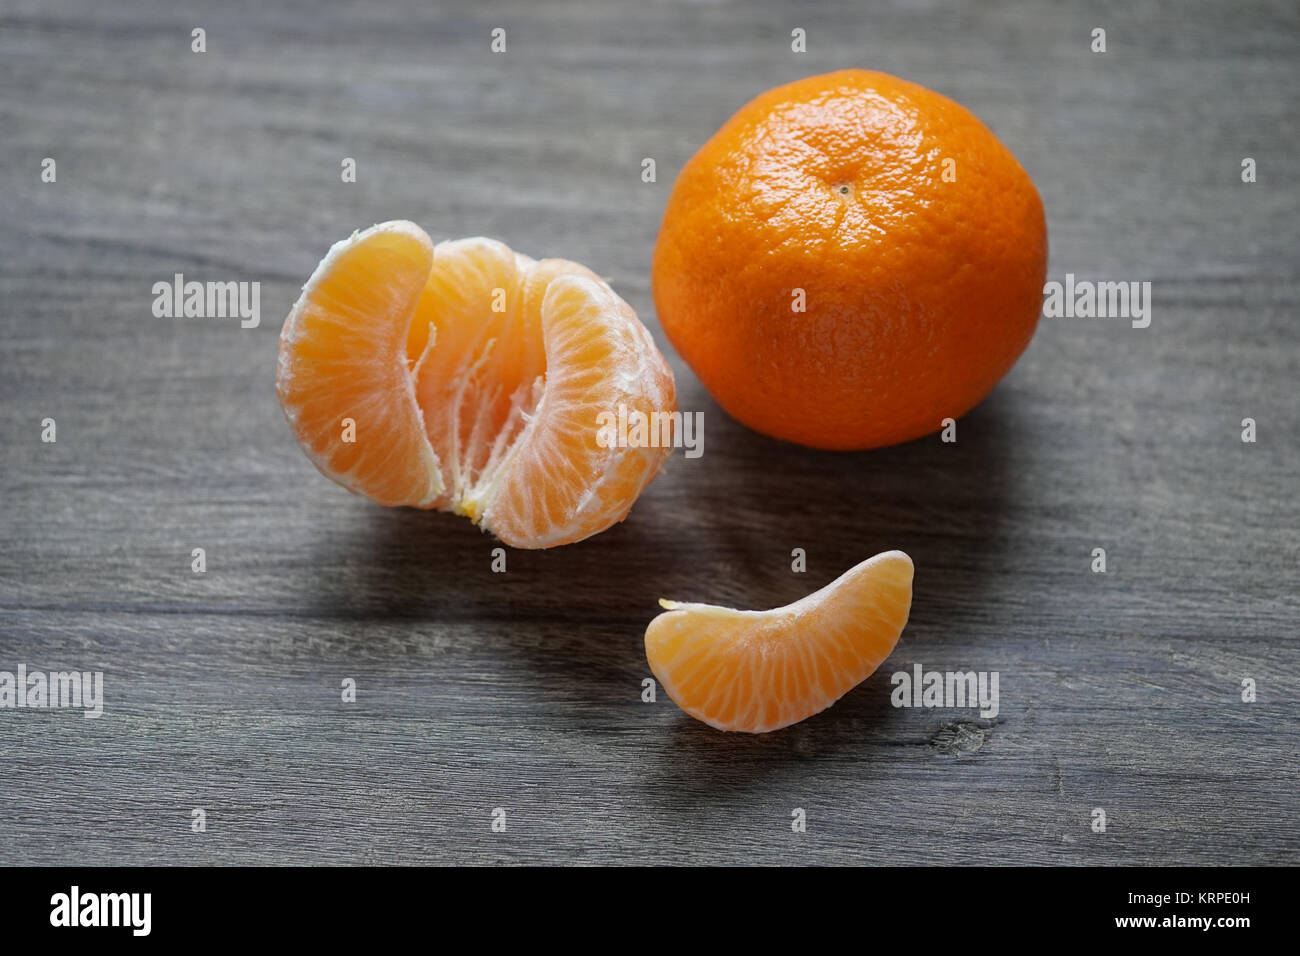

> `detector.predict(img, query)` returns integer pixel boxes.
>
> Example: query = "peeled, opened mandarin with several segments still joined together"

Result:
[276,221,676,548]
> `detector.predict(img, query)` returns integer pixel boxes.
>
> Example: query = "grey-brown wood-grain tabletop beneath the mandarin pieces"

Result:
[0,0,1300,864]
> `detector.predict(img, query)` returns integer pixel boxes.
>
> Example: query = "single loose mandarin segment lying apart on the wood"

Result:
[646,551,913,734]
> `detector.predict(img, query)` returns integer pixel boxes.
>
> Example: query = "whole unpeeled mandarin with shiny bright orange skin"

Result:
[651,70,1048,449]
